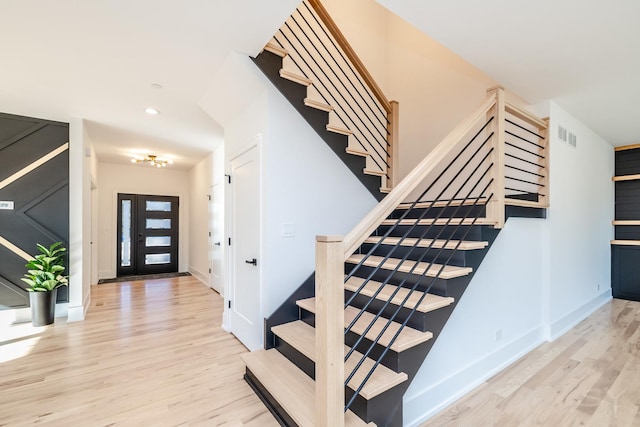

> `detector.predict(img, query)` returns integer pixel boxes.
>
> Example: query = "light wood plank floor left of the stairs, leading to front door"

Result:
[0,277,278,427]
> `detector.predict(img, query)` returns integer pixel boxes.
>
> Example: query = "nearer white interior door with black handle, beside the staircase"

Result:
[229,146,263,350]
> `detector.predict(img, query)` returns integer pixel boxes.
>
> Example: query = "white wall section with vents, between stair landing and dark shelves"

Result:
[546,102,614,339]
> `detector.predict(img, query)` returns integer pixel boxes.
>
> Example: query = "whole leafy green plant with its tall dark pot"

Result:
[22,242,68,326]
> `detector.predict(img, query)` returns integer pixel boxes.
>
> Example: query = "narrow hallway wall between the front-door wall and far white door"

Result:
[189,155,213,285]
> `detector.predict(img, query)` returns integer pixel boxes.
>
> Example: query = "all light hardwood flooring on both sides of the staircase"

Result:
[5,277,640,427]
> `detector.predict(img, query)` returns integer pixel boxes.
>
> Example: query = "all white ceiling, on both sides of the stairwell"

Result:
[0,0,640,169]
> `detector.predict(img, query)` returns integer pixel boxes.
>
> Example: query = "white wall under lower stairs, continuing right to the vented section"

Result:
[404,102,614,426]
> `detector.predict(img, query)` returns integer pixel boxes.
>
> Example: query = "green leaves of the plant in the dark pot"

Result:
[22,242,68,292]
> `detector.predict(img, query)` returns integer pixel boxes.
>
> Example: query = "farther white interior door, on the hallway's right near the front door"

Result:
[209,183,225,296]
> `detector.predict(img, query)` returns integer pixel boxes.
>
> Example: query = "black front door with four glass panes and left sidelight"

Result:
[117,194,180,277]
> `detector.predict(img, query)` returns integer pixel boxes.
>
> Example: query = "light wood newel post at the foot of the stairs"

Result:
[315,236,344,427]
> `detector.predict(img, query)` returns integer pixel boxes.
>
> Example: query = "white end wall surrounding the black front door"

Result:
[98,163,190,279]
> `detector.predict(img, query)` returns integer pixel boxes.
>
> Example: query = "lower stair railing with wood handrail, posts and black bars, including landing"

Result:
[316,87,548,425]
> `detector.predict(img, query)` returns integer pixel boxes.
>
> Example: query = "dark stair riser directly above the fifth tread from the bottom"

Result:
[359,244,473,267]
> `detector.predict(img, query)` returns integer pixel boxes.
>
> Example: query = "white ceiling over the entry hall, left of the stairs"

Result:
[0,0,298,169]
